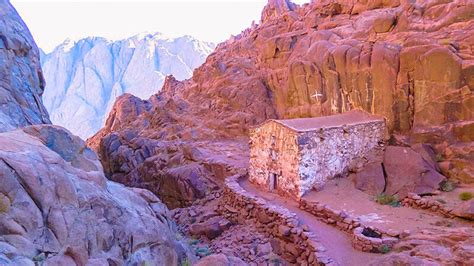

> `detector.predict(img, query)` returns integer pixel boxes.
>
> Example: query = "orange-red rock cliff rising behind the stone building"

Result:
[89,0,474,207]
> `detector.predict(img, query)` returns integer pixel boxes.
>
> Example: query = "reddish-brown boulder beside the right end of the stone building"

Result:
[383,146,446,198]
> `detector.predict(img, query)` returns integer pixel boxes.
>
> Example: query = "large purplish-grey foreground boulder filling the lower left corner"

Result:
[0,125,193,265]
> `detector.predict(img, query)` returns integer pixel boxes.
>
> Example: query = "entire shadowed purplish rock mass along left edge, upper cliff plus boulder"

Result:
[0,0,194,265]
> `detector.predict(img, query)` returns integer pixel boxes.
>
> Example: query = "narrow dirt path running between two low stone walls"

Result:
[240,179,383,266]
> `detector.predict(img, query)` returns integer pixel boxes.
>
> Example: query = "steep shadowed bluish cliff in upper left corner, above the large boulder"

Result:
[0,0,50,132]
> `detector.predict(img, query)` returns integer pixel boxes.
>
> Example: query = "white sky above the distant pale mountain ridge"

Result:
[11,0,309,52]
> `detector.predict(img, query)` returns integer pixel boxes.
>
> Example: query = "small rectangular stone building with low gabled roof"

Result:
[249,111,386,198]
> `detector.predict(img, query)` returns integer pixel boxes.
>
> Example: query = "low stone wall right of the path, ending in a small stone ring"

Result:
[299,199,400,253]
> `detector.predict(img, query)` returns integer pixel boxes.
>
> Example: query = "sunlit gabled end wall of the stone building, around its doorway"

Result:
[249,121,299,197]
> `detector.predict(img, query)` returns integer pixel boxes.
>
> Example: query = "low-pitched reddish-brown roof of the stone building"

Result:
[270,110,384,132]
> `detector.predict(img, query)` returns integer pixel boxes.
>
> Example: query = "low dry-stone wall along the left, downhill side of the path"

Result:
[218,175,336,265]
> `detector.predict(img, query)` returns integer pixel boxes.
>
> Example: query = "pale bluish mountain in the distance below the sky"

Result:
[40,33,215,139]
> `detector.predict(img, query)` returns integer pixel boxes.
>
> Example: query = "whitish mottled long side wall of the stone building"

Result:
[298,119,386,191]
